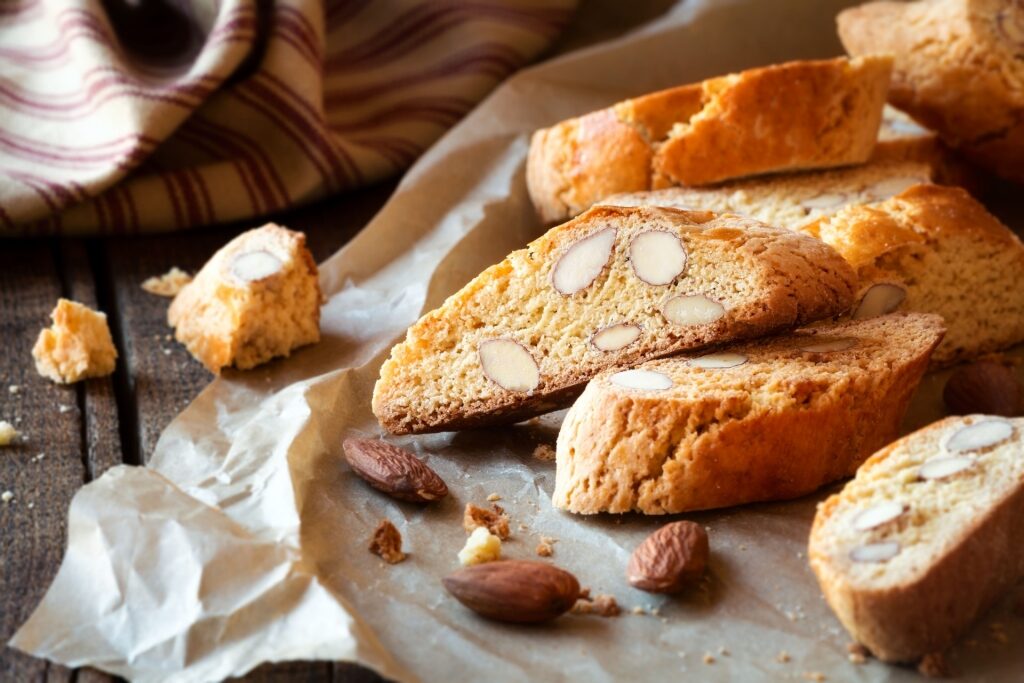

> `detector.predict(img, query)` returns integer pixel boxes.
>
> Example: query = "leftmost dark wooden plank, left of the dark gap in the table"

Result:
[0,242,87,681]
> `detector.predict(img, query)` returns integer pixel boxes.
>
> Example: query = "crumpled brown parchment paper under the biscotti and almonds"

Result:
[12,0,1024,682]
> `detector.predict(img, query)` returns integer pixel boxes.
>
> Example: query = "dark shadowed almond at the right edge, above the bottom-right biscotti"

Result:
[942,360,1024,418]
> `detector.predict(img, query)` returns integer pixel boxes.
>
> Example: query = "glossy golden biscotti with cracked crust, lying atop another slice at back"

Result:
[526,56,891,223]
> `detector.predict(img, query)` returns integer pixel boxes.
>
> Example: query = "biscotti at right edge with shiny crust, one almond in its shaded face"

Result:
[804,185,1024,367]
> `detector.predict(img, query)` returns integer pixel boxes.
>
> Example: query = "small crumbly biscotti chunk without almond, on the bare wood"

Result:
[32,299,118,384]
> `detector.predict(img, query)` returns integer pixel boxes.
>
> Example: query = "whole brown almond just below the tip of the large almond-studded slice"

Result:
[342,438,447,503]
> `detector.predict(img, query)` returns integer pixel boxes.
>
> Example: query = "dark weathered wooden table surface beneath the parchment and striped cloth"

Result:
[0,181,395,683]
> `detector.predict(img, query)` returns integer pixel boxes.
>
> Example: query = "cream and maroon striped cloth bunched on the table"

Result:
[0,0,577,236]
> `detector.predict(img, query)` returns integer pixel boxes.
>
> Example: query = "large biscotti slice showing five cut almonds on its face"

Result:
[373,206,853,434]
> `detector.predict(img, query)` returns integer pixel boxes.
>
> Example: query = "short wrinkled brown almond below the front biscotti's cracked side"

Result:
[626,521,709,593]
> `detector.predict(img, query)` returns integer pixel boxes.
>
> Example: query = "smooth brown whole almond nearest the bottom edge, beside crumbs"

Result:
[442,560,580,624]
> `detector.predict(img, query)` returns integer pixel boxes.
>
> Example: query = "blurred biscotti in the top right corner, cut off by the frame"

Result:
[839,0,1024,182]
